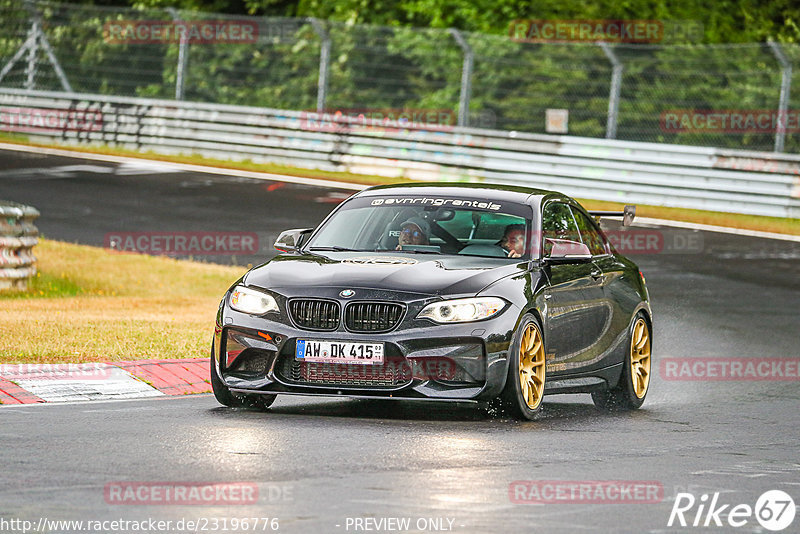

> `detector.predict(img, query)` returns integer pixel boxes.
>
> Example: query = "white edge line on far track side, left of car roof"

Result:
[0,143,362,191]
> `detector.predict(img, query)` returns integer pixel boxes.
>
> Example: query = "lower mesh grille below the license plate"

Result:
[275,355,410,388]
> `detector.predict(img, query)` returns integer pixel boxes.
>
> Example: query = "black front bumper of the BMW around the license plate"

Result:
[212,301,518,401]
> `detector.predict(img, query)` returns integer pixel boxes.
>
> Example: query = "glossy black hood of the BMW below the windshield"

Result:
[244,252,527,295]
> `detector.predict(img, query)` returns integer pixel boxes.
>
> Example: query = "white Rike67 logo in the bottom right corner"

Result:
[667,490,796,532]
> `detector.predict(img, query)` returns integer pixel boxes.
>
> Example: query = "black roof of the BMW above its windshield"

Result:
[358,182,565,202]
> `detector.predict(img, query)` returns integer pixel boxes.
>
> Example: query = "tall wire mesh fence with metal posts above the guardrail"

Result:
[0,0,800,153]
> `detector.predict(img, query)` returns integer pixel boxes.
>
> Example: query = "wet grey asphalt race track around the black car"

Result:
[0,151,800,532]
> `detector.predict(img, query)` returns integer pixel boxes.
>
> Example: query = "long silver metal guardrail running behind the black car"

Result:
[0,89,800,217]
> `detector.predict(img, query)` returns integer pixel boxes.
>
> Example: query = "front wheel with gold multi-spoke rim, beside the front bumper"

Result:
[500,314,546,421]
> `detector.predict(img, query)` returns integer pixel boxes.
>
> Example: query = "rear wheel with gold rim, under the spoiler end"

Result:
[592,312,652,411]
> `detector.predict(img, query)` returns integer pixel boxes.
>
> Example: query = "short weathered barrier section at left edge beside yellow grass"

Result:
[0,200,39,291]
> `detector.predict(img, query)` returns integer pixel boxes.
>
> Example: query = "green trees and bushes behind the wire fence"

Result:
[0,0,800,152]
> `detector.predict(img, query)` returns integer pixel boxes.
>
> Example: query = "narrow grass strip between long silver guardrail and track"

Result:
[0,133,800,235]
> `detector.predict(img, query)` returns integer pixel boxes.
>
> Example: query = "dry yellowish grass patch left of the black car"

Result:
[0,239,246,363]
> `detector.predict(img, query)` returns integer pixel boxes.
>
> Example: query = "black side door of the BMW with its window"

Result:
[541,201,603,371]
